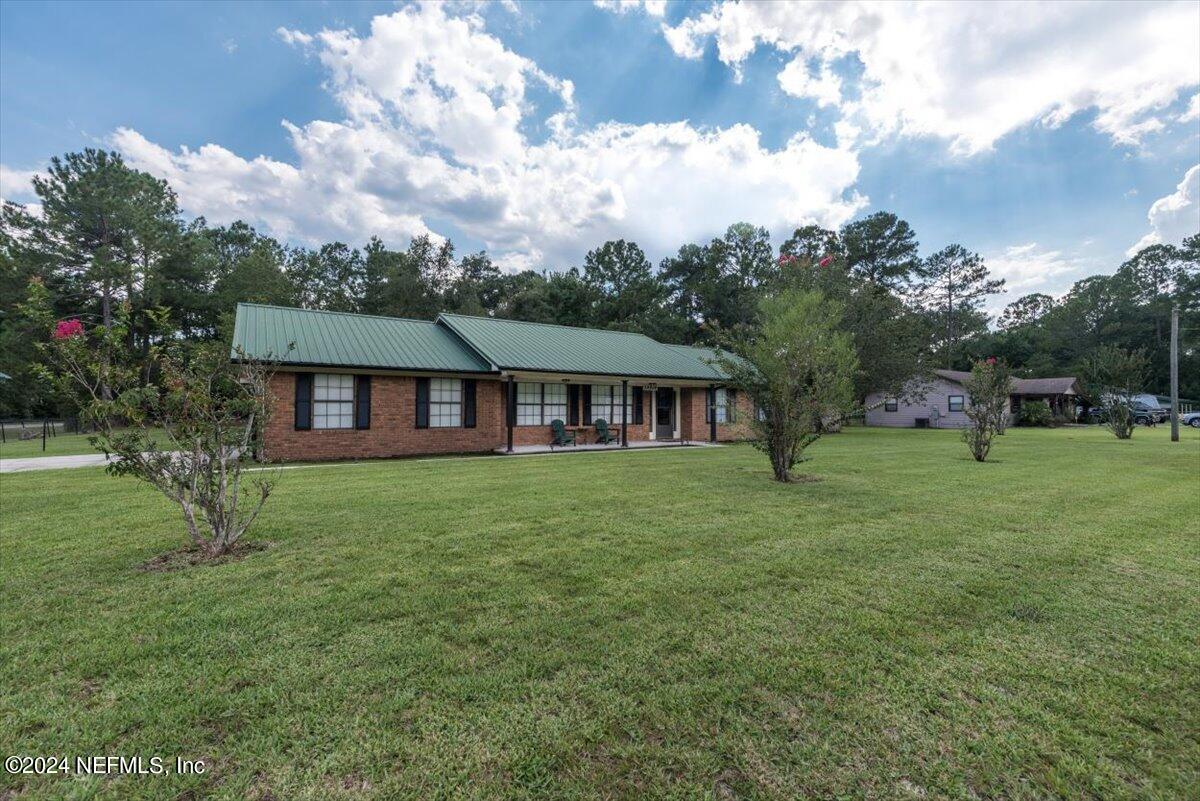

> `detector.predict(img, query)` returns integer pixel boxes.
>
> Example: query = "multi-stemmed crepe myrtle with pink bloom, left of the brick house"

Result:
[41,308,277,559]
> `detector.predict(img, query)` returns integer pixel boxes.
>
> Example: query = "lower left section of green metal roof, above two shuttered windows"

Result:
[230,303,491,373]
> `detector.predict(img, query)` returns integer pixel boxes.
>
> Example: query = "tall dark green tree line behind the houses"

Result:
[0,150,1200,416]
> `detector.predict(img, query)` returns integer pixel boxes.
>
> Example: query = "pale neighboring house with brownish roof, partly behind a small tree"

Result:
[866,369,1080,428]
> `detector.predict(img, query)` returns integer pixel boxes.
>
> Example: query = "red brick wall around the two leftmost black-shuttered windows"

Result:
[264,373,505,460]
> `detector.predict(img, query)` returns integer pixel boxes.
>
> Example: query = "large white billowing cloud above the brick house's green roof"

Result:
[112,4,866,267]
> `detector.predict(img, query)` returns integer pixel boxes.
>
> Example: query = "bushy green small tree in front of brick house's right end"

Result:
[716,290,858,482]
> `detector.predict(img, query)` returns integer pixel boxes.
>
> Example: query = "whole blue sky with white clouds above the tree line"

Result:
[0,2,1200,309]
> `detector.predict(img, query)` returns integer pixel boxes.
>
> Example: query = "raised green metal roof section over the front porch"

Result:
[438,314,725,381]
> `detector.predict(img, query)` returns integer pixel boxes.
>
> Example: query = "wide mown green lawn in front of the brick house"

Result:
[0,428,1200,800]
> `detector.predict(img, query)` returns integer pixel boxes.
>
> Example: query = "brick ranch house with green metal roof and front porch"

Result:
[232,303,751,460]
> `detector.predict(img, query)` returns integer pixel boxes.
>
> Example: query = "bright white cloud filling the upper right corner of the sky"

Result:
[664,1,1200,155]
